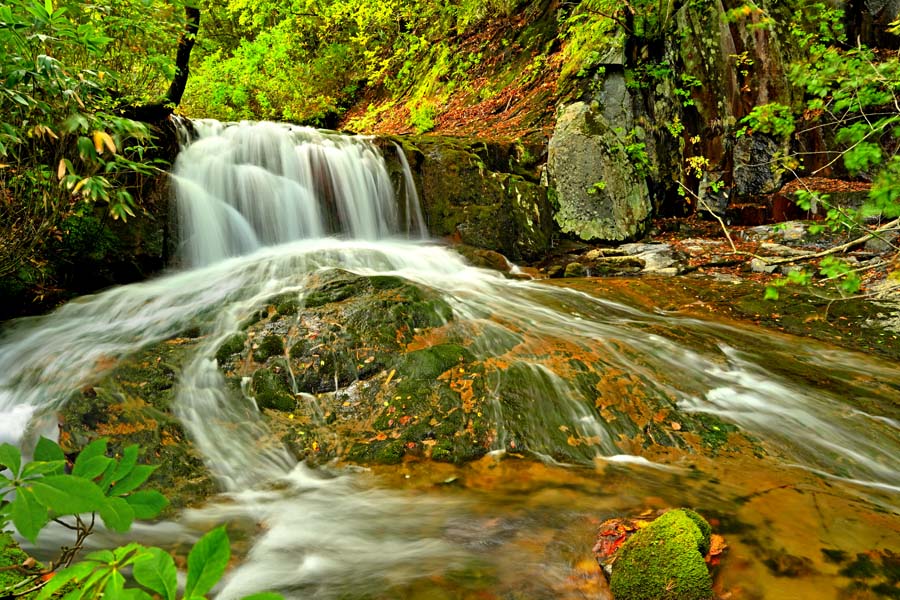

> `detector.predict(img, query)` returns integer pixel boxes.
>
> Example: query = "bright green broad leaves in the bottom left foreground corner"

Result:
[0,438,281,600]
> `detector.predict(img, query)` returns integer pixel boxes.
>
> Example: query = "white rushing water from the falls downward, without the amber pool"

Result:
[0,123,900,598]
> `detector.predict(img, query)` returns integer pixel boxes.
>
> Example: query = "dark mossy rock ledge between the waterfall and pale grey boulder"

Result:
[381,137,554,261]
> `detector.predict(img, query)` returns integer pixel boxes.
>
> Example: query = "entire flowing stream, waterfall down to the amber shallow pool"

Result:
[0,121,900,598]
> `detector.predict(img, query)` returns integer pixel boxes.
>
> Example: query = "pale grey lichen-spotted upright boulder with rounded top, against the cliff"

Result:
[547,102,652,241]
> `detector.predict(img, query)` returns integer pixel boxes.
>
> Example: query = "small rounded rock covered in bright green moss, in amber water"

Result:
[610,509,713,600]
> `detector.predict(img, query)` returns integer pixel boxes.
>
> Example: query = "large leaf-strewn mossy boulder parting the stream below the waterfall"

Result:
[226,270,493,463]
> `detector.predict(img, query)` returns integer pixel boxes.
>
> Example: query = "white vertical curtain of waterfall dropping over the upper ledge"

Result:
[172,120,426,267]
